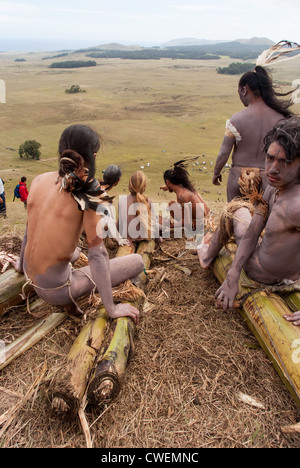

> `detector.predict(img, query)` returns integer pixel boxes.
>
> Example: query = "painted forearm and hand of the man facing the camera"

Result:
[215,214,266,310]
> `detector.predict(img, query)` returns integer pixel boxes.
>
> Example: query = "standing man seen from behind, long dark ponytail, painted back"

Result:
[213,66,293,201]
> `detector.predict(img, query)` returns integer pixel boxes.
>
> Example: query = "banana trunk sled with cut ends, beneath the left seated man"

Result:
[49,241,155,415]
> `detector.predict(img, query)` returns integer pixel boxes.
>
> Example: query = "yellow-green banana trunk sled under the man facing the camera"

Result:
[212,245,300,408]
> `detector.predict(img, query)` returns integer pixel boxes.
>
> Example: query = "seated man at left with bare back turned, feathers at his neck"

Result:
[9,125,144,322]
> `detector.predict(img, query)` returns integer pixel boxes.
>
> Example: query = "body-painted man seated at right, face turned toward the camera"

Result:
[198,117,300,325]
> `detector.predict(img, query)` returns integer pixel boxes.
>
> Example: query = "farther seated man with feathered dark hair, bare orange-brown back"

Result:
[160,161,210,233]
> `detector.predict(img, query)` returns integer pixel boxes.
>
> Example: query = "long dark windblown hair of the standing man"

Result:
[239,66,294,118]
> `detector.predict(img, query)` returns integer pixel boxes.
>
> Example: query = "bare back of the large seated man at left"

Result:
[24,172,83,281]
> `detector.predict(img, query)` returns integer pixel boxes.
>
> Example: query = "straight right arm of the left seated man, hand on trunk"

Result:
[83,210,139,323]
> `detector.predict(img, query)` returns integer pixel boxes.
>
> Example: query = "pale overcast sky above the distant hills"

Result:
[0,0,300,51]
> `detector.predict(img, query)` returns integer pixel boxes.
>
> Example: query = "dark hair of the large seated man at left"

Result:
[58,125,102,186]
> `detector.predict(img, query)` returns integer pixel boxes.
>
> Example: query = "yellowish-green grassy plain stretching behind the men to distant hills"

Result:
[0,53,300,234]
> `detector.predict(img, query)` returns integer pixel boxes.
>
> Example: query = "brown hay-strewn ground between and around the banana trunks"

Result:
[0,239,300,448]
